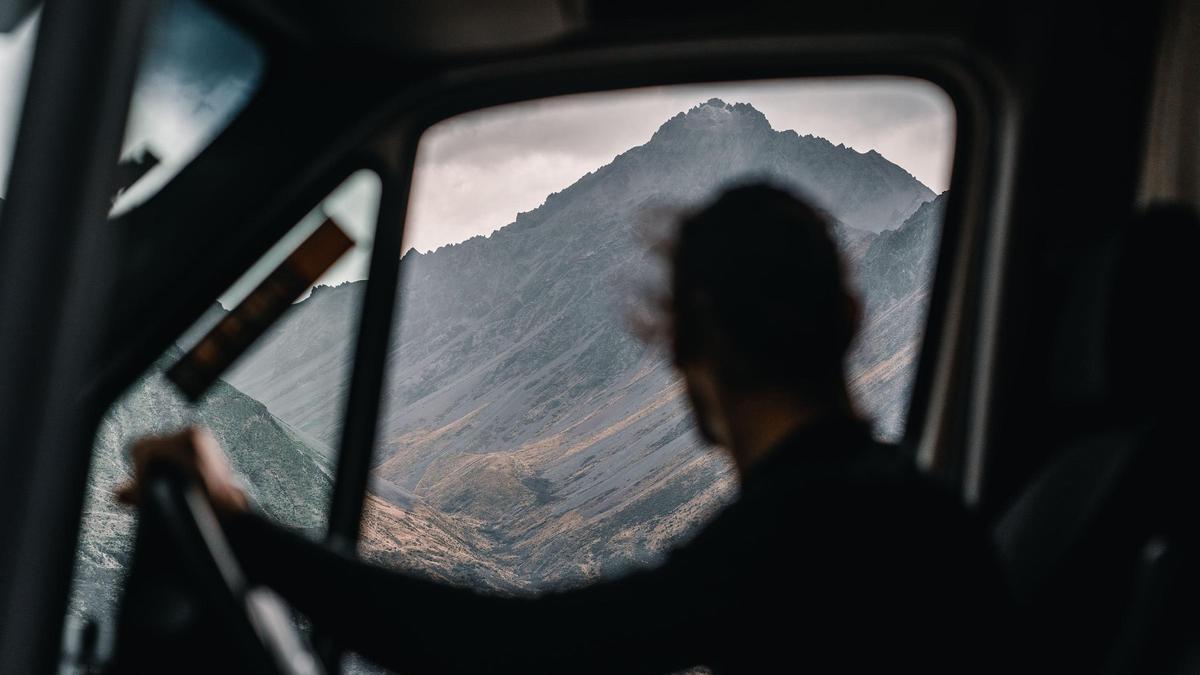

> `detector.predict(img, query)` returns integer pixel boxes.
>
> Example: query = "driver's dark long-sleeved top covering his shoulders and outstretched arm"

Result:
[228,420,1004,673]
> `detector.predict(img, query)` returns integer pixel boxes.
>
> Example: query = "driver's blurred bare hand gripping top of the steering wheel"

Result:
[116,426,247,513]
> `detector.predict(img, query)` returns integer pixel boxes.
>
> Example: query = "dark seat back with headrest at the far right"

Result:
[994,207,1200,675]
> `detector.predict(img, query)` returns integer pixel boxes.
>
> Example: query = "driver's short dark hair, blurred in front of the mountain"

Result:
[667,184,858,394]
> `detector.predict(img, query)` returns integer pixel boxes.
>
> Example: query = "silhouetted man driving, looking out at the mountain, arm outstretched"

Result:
[127,185,1001,673]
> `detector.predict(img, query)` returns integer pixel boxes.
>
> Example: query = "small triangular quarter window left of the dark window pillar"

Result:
[68,171,380,635]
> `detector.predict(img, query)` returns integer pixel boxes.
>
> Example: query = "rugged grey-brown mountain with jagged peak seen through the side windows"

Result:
[229,100,944,590]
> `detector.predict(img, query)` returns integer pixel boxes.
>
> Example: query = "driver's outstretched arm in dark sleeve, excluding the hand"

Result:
[226,513,736,673]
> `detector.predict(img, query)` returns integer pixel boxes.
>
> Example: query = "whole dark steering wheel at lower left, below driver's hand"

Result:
[112,461,323,675]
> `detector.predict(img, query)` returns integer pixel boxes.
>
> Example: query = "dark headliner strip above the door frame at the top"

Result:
[213,0,979,56]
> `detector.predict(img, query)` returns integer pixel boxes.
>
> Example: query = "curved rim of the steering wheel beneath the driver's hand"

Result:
[139,461,322,675]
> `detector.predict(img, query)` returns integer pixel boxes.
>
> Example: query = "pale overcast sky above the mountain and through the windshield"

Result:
[0,7,954,283]
